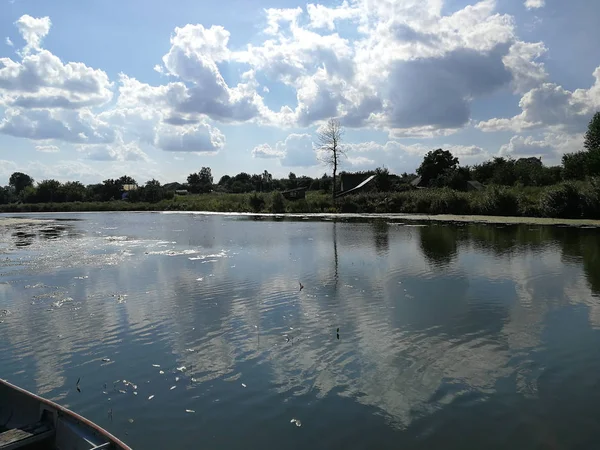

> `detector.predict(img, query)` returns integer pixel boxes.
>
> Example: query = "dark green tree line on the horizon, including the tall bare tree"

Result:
[0,112,600,204]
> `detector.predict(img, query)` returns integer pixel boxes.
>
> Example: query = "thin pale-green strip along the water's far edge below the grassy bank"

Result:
[0,210,600,228]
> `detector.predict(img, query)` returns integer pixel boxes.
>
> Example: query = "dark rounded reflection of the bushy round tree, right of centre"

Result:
[419,225,458,266]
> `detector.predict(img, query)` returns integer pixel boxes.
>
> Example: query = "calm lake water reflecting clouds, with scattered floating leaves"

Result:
[0,213,600,450]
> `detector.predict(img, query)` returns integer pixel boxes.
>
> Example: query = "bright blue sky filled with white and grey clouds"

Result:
[0,0,600,184]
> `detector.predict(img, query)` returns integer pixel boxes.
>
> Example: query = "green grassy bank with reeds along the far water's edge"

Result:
[0,180,600,219]
